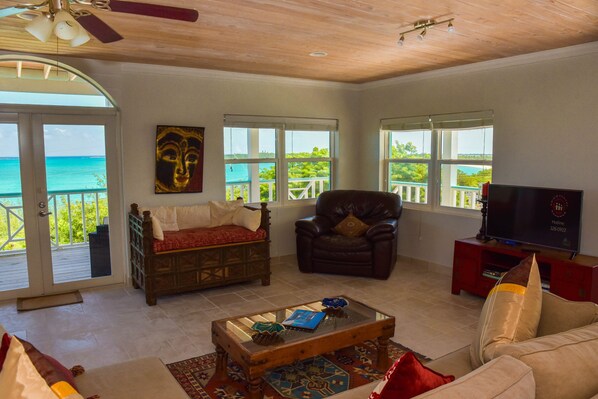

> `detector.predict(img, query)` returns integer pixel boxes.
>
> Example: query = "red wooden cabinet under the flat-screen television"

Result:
[451,238,598,303]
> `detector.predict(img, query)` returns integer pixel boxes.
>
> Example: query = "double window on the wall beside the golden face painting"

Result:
[224,115,337,202]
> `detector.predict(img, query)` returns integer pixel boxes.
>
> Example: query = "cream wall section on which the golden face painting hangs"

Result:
[59,59,360,256]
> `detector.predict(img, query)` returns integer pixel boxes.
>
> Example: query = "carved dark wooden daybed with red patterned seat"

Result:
[129,202,270,306]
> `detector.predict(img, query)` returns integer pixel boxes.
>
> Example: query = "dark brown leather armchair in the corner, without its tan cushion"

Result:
[295,190,403,279]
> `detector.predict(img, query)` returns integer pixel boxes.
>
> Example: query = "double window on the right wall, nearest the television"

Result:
[381,111,493,209]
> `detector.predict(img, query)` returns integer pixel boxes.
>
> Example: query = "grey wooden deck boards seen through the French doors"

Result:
[0,245,91,291]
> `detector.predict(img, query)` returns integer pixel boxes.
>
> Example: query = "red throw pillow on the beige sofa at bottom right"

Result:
[369,352,455,399]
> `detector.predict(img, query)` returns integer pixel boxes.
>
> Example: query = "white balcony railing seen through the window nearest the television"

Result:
[391,181,481,209]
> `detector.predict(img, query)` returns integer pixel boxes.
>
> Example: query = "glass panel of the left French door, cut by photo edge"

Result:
[0,123,29,292]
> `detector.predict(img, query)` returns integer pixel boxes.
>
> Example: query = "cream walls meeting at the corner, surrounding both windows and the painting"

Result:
[47,43,598,274]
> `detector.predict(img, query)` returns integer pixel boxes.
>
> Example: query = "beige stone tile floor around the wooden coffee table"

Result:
[0,257,483,368]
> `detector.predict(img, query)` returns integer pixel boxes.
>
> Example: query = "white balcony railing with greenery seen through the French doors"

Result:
[0,188,107,255]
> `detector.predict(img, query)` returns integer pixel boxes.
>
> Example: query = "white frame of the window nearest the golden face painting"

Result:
[223,115,338,206]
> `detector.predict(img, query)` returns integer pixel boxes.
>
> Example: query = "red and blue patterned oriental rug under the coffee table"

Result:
[166,341,430,399]
